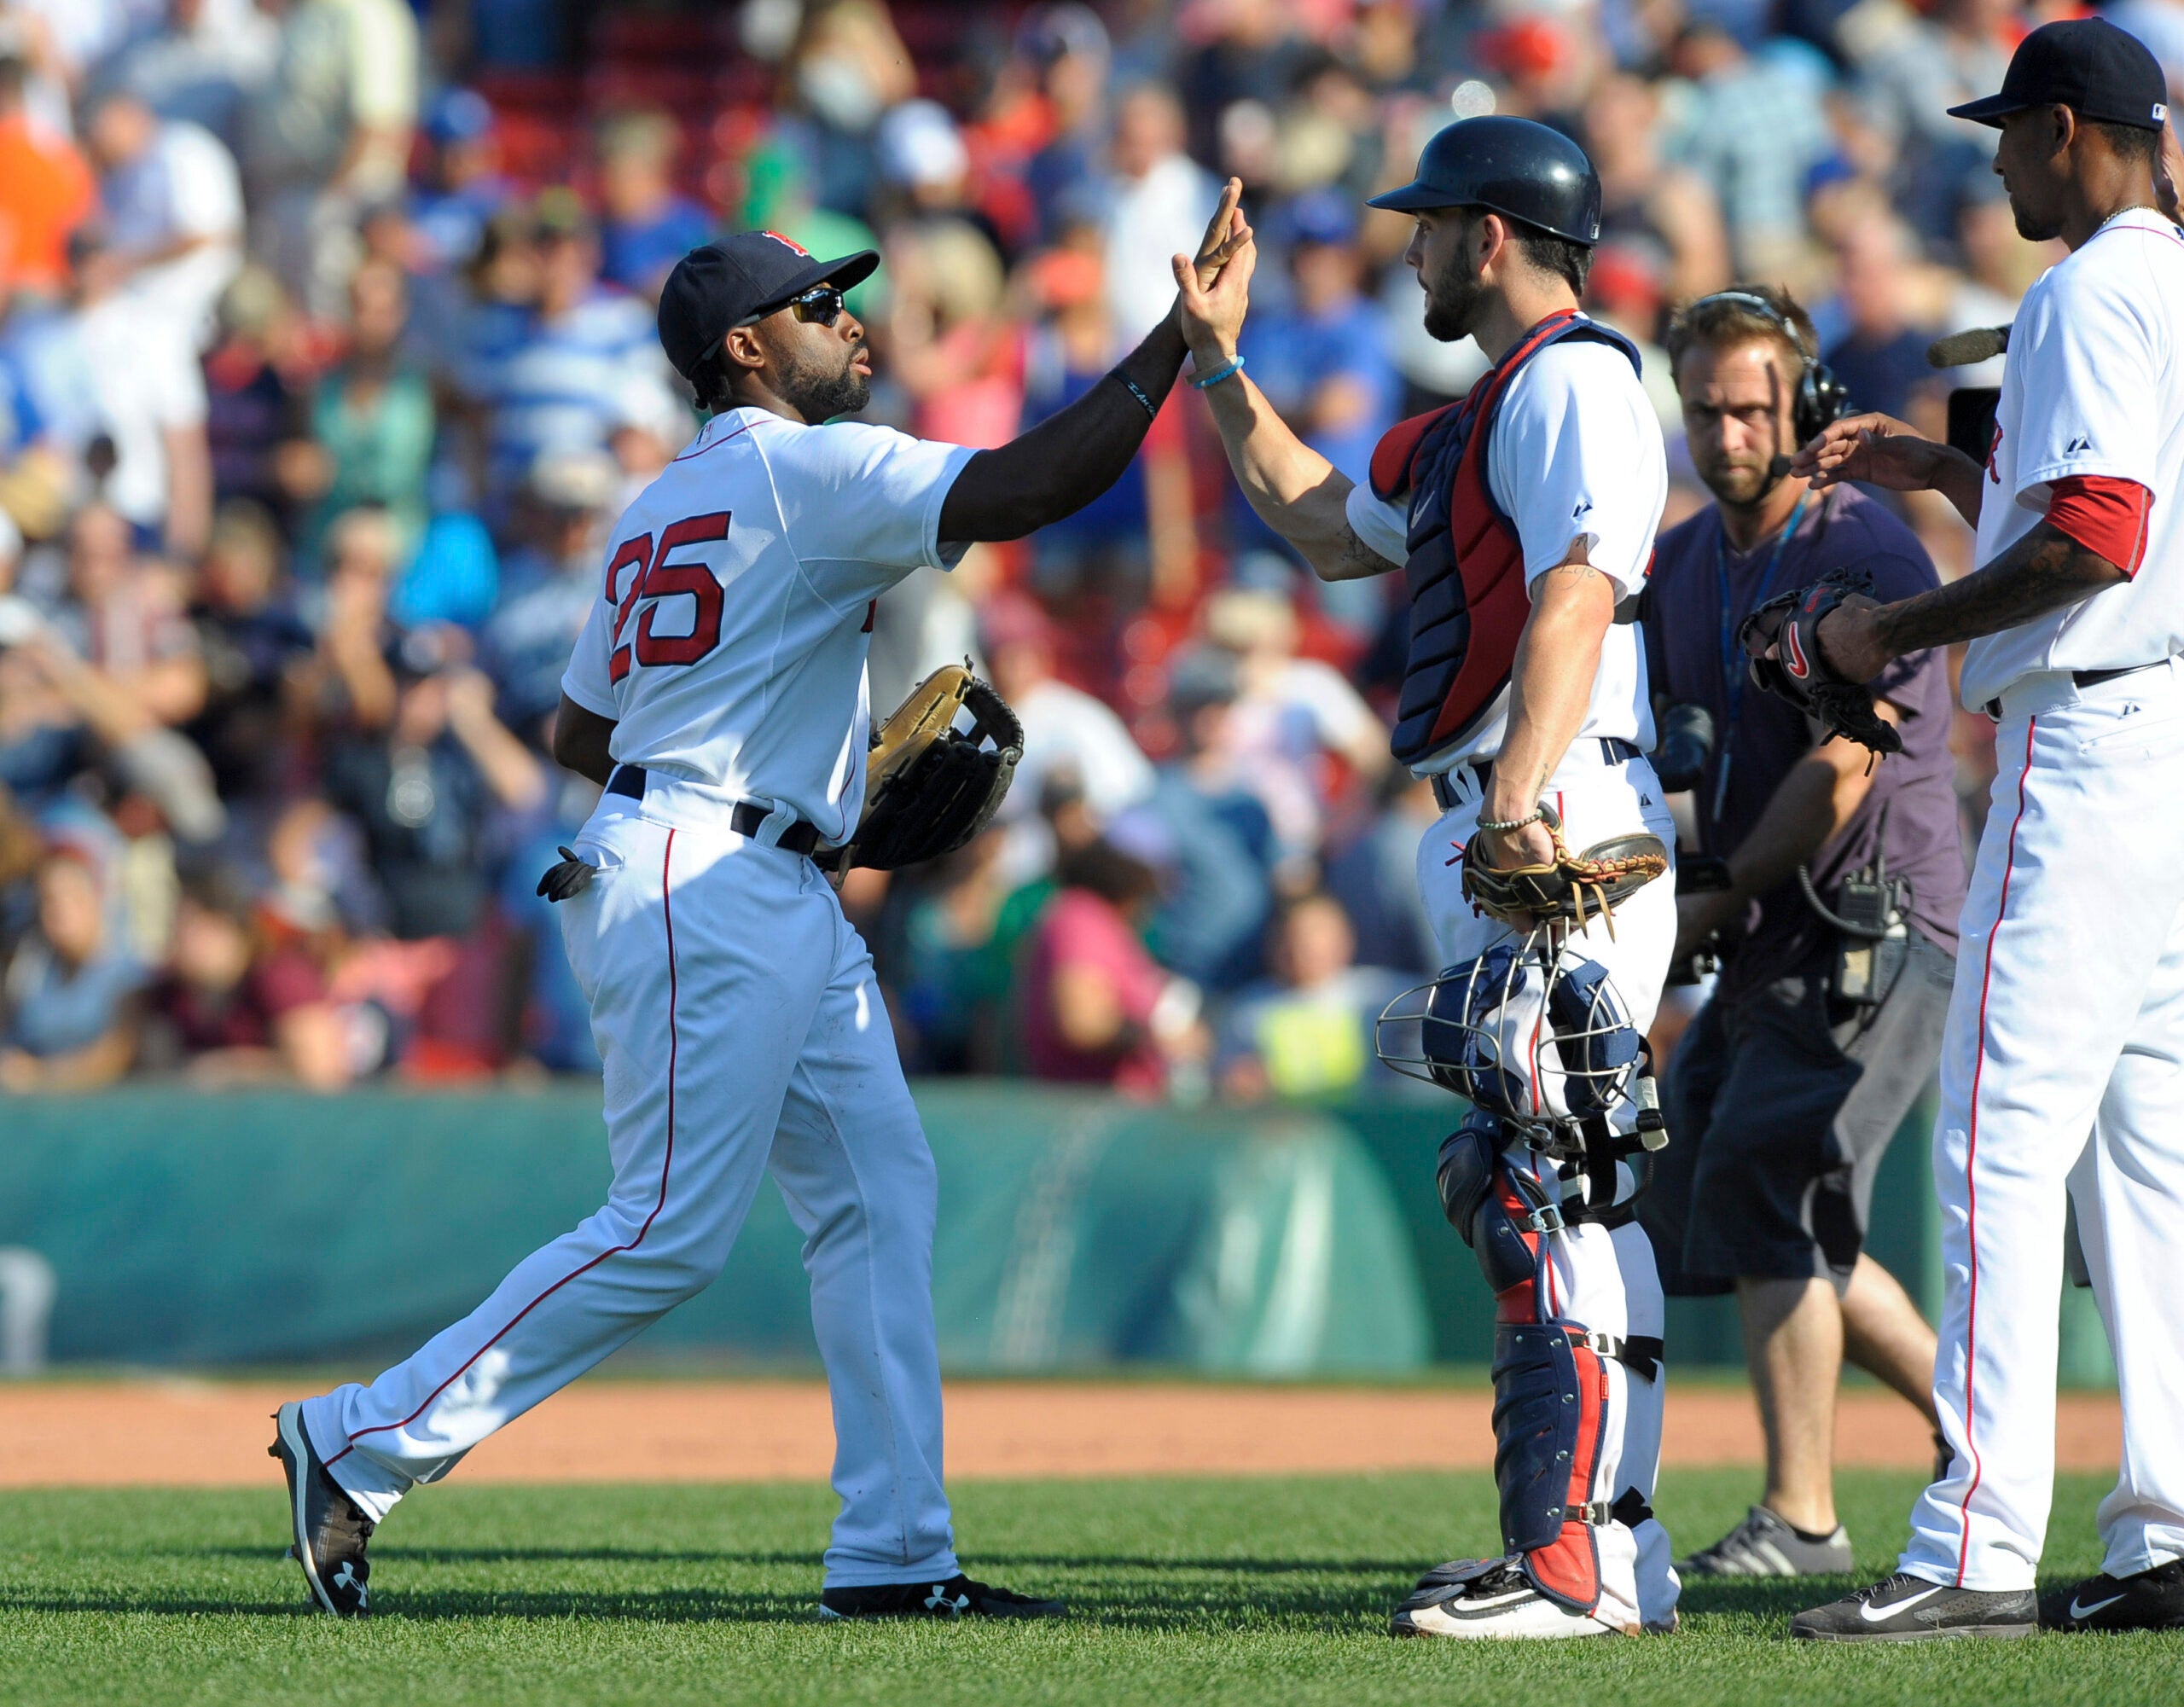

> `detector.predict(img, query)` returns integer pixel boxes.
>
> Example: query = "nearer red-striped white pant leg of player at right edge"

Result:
[1902,707,2184,1591]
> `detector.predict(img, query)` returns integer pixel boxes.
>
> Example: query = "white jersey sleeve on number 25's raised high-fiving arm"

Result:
[760,421,976,607]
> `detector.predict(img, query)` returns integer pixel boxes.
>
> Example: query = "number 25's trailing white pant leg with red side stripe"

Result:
[304,816,841,1517]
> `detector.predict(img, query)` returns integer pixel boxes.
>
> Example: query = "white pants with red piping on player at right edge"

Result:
[1902,659,2184,1589]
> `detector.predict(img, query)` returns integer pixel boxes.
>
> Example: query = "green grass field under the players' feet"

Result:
[0,1472,2184,1707]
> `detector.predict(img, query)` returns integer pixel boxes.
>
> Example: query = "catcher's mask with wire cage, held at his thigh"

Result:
[1374,930,1642,1129]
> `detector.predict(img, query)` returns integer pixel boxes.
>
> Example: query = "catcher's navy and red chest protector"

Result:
[1372,310,1638,764]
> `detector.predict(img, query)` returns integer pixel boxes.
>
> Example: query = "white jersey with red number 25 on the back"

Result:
[561,409,974,843]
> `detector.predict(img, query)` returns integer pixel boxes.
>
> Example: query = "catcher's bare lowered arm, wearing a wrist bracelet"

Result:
[1478,539,1616,867]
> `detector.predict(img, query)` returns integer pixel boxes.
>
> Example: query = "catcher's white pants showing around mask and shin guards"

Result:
[1417,755,1682,1626]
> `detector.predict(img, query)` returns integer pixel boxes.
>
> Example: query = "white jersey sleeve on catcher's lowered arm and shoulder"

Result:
[1487,339,1669,598]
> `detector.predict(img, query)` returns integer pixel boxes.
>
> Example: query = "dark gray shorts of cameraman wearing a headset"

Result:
[1638,932,1957,1297]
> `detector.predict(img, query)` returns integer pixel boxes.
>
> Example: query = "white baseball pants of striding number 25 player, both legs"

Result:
[304,777,956,1587]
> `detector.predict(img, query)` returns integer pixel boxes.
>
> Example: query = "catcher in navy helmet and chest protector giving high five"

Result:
[1182,118,1677,1637]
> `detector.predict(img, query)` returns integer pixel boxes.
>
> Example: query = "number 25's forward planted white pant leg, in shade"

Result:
[773,919,956,1587]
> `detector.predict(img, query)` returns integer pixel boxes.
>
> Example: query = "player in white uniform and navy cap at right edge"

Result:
[1791,20,2184,1641]
